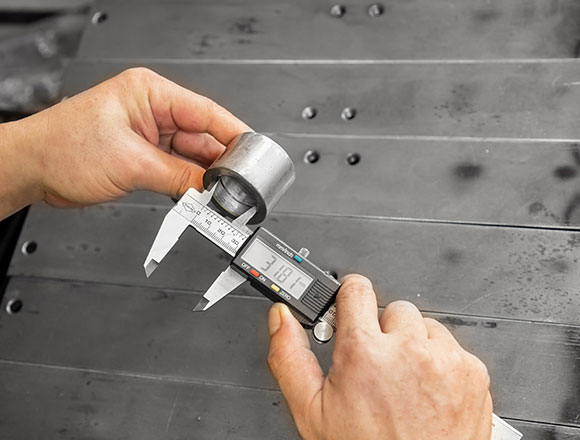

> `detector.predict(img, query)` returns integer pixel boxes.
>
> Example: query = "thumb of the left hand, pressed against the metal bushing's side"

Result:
[134,140,205,198]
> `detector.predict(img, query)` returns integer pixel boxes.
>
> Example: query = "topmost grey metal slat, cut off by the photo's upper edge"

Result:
[79,0,580,60]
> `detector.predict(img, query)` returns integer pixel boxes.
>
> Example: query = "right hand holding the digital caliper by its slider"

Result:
[268,275,492,440]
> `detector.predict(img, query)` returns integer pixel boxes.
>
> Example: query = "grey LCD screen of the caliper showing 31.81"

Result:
[242,239,312,299]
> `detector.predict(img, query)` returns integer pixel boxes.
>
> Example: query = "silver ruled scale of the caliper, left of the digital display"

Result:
[175,197,248,256]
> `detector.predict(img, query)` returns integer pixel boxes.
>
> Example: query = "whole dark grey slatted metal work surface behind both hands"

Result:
[0,0,580,440]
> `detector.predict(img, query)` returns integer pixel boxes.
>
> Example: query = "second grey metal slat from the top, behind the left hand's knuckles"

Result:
[65,60,580,139]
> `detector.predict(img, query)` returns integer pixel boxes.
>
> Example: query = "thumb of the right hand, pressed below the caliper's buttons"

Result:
[268,303,324,426]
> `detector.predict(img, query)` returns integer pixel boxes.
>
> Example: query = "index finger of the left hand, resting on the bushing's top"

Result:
[151,73,253,145]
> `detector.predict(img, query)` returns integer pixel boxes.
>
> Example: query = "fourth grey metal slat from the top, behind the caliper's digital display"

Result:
[10,205,580,324]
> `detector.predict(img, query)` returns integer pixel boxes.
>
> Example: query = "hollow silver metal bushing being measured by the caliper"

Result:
[203,132,295,224]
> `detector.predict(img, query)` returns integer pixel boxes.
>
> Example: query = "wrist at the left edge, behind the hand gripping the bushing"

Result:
[0,118,44,218]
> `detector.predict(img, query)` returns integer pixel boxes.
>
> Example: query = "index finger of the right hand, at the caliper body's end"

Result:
[336,275,380,339]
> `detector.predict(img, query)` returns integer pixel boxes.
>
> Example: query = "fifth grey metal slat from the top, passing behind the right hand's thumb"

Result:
[0,279,580,426]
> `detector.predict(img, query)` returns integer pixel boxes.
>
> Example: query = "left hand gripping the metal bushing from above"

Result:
[0,68,250,215]
